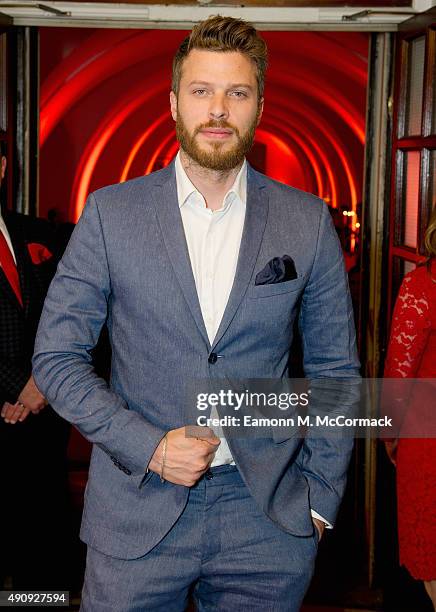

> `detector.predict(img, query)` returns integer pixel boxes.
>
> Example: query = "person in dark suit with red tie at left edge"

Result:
[0,145,69,589]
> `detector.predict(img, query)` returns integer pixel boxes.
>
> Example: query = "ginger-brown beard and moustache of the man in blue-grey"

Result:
[176,113,258,172]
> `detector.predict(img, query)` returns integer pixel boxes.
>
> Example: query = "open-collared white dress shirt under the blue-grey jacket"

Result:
[175,153,328,525]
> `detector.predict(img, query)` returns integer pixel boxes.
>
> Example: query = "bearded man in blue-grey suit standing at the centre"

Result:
[34,16,359,612]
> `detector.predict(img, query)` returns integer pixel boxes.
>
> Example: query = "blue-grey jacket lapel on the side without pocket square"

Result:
[153,162,210,347]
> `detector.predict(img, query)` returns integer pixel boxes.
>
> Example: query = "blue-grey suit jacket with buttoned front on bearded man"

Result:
[33,163,359,559]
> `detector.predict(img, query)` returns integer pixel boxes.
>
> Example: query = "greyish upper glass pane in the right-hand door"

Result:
[405,36,425,136]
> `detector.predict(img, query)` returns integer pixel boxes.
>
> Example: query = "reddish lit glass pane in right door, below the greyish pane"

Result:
[396,151,421,249]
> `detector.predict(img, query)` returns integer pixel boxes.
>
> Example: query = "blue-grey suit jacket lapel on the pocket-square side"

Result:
[212,166,268,350]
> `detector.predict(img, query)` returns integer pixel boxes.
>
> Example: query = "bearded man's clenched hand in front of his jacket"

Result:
[148,427,221,487]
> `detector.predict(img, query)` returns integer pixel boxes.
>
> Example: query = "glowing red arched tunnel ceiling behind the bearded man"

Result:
[40,28,368,221]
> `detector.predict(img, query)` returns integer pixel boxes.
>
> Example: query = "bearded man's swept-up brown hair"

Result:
[171,15,268,101]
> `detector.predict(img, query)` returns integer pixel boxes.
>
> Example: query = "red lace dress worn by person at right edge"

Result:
[385,259,436,581]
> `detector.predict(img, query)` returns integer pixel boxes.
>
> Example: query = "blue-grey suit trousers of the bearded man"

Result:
[81,466,318,612]
